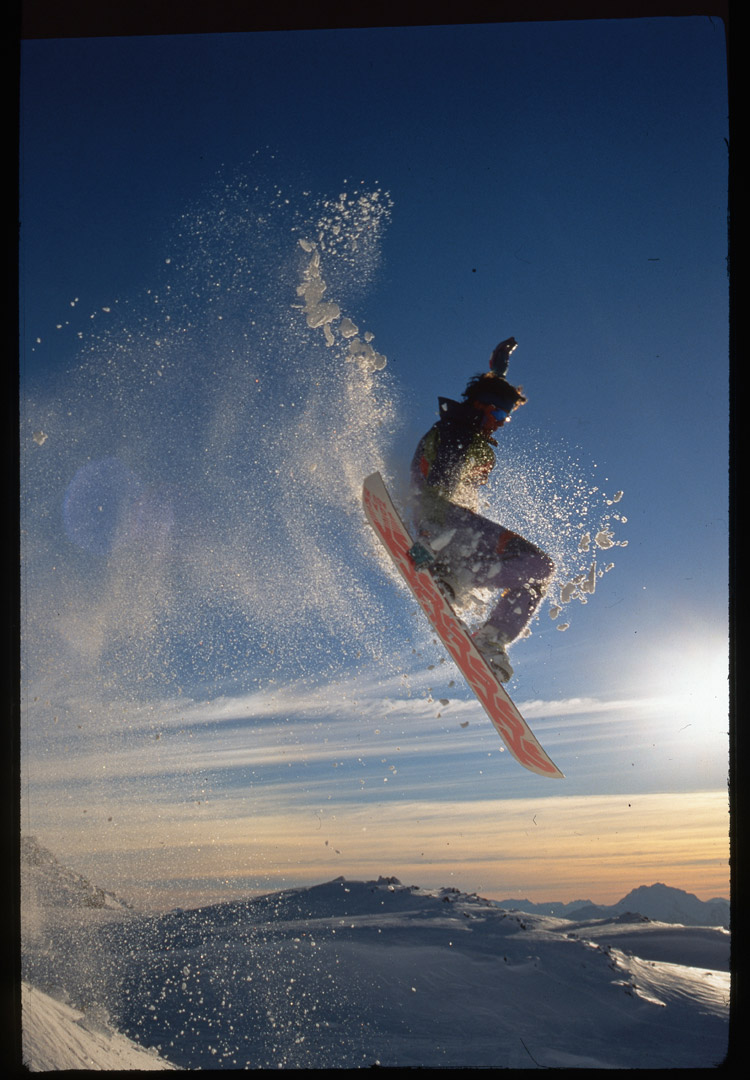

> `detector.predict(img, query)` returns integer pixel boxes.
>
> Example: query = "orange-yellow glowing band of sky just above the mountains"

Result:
[32,792,729,909]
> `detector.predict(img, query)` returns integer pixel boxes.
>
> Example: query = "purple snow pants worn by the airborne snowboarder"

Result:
[415,502,554,644]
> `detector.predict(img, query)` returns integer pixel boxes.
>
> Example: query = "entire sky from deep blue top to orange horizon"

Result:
[21,17,728,904]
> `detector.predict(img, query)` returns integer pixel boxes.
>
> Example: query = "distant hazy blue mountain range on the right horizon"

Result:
[498,882,729,930]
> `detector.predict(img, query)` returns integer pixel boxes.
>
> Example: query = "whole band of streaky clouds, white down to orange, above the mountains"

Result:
[23,670,727,905]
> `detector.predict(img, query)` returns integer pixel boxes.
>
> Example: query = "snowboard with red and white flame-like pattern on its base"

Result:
[362,473,563,778]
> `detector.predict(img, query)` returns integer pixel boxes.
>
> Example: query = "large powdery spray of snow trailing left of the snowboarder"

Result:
[24,171,398,708]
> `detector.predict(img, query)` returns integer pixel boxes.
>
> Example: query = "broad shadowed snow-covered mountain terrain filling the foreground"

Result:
[23,838,729,1069]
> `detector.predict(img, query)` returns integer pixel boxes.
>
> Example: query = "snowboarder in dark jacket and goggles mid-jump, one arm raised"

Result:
[412,338,554,683]
